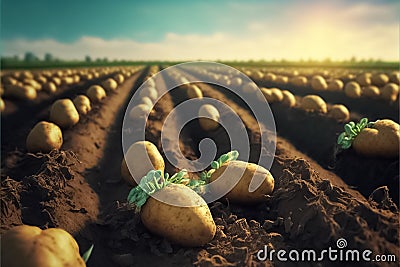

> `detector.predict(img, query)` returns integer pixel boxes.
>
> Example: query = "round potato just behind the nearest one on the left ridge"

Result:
[50,98,79,128]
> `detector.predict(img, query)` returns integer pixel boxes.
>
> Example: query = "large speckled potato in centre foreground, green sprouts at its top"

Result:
[141,184,216,247]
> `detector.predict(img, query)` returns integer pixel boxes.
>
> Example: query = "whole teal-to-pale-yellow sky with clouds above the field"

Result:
[1,0,399,59]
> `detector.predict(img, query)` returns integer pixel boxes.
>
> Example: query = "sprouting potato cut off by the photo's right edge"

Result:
[352,119,400,158]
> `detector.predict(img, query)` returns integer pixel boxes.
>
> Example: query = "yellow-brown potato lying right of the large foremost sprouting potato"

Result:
[210,160,274,203]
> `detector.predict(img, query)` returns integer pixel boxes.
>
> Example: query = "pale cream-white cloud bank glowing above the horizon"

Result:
[3,1,399,60]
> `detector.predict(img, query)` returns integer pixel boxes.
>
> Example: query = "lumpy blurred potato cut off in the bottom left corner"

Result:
[1,225,86,267]
